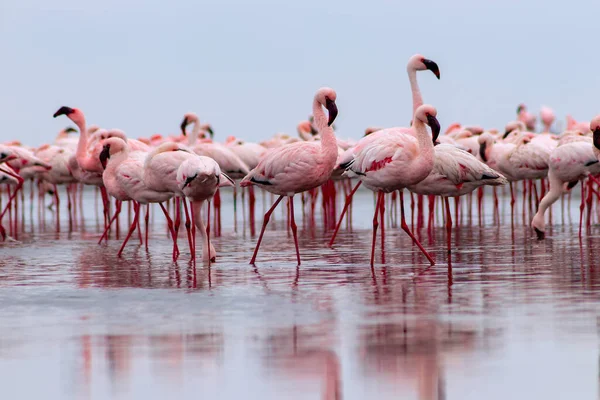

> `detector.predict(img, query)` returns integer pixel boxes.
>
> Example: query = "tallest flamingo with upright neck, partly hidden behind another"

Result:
[329,54,440,247]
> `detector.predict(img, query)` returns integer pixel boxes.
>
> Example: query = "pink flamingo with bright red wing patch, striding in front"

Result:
[342,104,440,267]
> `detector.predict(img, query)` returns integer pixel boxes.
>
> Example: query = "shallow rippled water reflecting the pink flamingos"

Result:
[0,191,600,399]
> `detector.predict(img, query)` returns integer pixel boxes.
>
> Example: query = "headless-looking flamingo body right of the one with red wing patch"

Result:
[408,144,508,253]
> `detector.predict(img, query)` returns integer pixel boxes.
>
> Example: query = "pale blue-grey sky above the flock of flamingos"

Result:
[0,0,600,145]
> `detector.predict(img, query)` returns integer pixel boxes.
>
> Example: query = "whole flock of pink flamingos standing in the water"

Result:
[0,54,600,266]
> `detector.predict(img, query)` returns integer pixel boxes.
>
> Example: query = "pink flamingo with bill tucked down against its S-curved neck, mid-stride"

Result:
[241,87,338,265]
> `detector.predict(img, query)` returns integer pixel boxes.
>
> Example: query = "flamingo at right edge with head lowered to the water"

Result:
[531,115,600,240]
